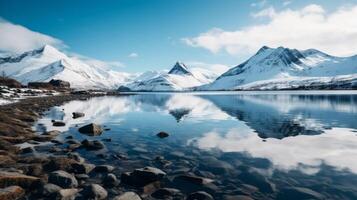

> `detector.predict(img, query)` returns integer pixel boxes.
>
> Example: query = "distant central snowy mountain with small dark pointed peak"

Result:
[126,62,211,91]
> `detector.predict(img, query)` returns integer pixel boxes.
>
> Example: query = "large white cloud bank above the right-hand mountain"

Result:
[183,4,357,56]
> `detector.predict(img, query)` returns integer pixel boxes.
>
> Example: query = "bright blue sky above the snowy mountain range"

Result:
[0,0,357,72]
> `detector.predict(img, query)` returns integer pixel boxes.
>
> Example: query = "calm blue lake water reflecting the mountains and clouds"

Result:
[37,91,357,199]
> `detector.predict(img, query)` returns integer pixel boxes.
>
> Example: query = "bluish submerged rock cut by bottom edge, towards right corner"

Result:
[277,187,324,200]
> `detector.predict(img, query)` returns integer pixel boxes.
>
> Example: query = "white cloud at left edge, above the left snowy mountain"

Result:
[0,18,65,53]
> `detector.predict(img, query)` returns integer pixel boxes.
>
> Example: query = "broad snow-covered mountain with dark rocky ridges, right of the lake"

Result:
[198,46,357,90]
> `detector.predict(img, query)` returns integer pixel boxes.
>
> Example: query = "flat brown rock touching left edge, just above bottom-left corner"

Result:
[0,171,40,188]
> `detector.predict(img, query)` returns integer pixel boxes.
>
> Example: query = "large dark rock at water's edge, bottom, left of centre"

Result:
[121,167,166,187]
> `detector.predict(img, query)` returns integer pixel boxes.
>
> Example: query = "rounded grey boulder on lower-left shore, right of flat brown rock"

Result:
[48,170,78,188]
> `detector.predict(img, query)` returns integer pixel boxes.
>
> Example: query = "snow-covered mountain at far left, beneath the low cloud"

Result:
[0,45,132,89]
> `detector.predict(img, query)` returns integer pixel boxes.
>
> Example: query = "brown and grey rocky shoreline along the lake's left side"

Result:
[0,94,222,200]
